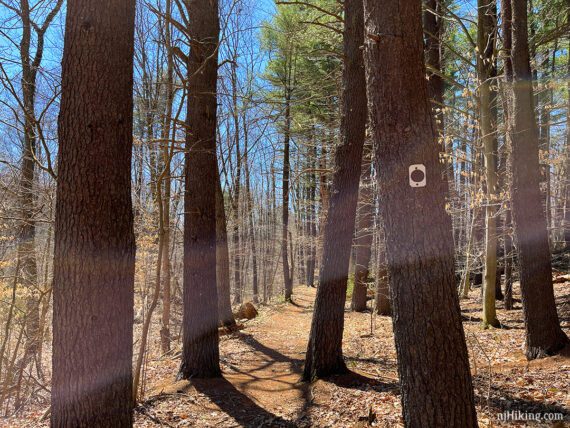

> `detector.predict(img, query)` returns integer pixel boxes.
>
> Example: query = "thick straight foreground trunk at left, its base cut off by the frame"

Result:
[51,0,135,427]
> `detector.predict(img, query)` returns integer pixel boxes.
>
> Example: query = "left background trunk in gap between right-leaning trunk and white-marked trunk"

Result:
[351,144,374,312]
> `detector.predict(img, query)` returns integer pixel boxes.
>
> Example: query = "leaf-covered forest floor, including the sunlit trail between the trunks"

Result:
[4,276,570,427]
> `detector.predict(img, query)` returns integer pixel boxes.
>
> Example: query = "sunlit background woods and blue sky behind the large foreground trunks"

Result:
[0,0,570,422]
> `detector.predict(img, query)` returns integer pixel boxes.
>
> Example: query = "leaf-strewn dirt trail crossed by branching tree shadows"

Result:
[137,287,315,426]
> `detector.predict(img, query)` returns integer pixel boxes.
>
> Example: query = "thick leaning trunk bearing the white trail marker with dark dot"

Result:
[364,0,477,428]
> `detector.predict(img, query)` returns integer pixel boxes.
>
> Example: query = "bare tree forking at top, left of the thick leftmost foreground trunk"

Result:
[8,0,63,407]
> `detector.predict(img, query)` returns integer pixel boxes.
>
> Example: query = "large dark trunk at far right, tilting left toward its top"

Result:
[509,0,568,359]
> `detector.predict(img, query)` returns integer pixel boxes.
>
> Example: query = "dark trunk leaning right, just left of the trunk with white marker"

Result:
[303,0,367,380]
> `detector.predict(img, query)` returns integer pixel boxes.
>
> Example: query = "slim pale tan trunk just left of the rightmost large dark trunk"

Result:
[477,0,500,327]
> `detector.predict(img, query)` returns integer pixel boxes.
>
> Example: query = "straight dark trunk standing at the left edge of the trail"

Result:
[178,0,221,379]
